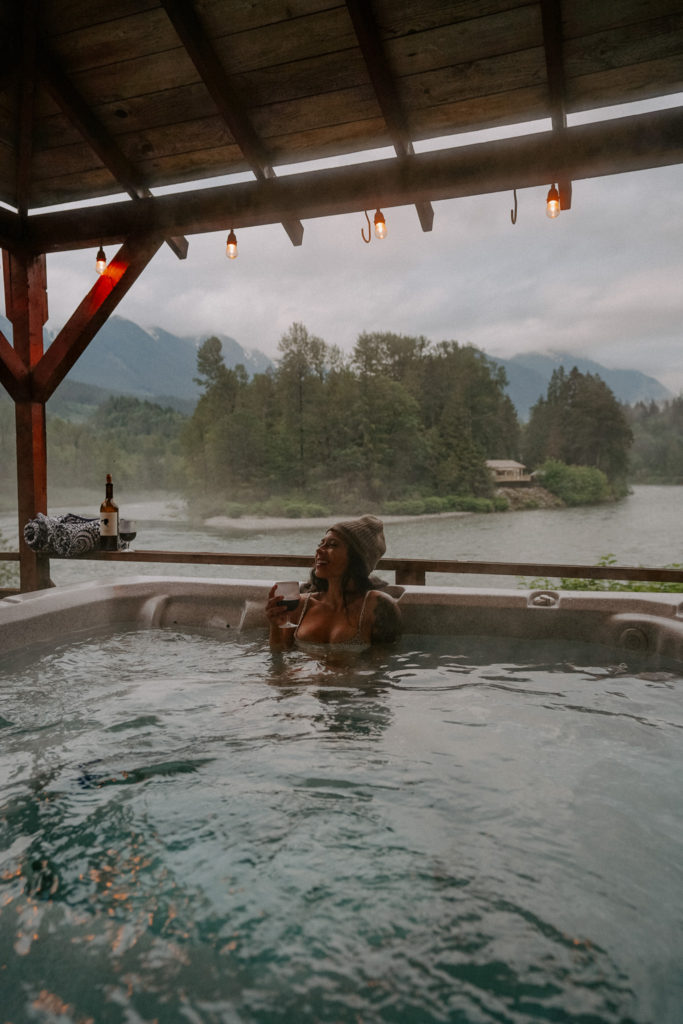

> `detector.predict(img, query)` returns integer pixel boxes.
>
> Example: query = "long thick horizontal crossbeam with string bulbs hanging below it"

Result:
[27,106,683,252]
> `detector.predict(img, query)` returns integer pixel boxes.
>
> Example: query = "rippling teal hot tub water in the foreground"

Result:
[0,629,683,1024]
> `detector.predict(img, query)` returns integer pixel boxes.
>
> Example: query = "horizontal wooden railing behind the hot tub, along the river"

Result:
[0,551,683,594]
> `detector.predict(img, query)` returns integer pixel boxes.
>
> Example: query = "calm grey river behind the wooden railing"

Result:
[0,485,683,587]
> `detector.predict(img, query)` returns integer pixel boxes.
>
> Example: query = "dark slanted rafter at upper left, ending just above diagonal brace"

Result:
[39,46,187,259]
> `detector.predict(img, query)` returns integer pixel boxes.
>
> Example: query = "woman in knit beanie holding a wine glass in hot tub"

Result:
[265,515,400,652]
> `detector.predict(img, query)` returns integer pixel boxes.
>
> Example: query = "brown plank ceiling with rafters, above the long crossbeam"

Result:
[5,0,683,216]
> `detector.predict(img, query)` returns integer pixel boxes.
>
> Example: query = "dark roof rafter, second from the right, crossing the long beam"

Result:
[346,0,434,231]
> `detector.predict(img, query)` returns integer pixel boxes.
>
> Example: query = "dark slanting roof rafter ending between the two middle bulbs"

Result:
[162,0,303,246]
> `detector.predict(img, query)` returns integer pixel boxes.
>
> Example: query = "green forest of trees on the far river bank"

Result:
[0,324,683,515]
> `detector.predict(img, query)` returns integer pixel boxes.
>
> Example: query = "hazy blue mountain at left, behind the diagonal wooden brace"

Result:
[0,316,272,412]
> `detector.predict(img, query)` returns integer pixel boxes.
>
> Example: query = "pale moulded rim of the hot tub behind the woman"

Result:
[0,577,683,664]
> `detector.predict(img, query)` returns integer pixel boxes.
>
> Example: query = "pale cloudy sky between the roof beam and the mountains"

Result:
[36,96,683,394]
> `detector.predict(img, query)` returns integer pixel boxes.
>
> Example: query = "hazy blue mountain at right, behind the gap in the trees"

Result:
[494,352,673,420]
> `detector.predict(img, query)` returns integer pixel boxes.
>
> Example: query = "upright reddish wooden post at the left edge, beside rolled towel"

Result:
[3,246,51,592]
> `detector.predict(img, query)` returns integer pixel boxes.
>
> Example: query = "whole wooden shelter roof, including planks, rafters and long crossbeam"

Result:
[0,0,683,255]
